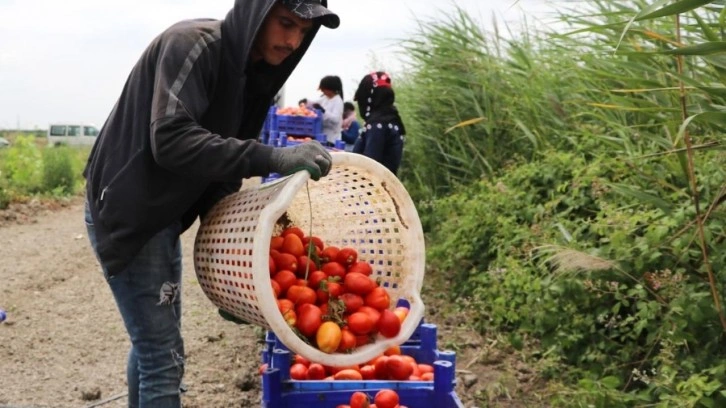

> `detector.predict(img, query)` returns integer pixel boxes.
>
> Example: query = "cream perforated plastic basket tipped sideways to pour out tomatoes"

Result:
[194,152,425,366]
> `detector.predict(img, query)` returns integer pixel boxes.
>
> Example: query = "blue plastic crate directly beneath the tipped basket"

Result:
[262,322,463,408]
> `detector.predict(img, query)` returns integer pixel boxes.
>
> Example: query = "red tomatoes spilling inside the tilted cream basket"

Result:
[270,226,408,353]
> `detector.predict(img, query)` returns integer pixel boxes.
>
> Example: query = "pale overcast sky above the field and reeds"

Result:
[0,0,546,129]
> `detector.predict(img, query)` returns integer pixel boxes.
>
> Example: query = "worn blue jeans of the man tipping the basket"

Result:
[85,203,184,408]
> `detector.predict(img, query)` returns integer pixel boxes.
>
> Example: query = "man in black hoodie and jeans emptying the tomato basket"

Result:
[84,0,340,408]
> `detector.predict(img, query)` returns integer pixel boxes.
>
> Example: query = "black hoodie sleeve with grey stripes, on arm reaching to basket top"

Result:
[150,26,272,182]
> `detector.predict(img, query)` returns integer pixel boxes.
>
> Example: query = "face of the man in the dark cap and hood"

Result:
[252,3,313,65]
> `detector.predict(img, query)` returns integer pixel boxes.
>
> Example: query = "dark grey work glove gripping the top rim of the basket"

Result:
[270,140,333,181]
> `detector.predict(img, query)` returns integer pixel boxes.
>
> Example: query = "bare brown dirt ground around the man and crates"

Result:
[0,193,535,408]
